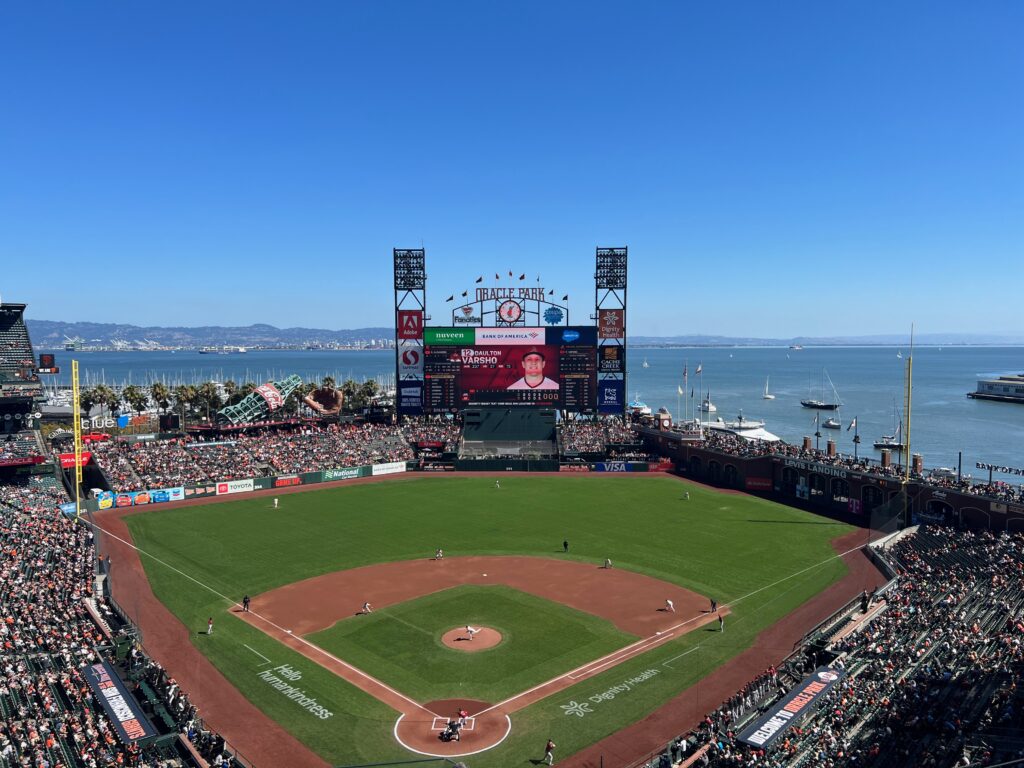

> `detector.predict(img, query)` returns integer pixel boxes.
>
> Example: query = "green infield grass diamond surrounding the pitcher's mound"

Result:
[307,586,637,703]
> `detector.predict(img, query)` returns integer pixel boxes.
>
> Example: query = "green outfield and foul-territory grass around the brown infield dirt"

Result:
[126,476,850,768]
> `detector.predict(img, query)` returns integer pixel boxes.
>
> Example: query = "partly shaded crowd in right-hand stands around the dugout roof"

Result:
[648,527,1024,768]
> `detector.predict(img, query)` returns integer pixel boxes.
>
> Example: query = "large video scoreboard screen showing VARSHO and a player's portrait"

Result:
[423,326,597,414]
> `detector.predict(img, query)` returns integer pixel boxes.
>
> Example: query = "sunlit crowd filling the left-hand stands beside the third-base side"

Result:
[0,475,201,768]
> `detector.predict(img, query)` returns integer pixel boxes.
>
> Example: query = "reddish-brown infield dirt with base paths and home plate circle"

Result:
[238,556,728,757]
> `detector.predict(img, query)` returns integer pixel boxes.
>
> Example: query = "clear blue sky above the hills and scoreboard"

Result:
[0,0,1024,337]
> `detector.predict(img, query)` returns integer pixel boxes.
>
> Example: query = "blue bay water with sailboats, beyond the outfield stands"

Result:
[49,346,1024,482]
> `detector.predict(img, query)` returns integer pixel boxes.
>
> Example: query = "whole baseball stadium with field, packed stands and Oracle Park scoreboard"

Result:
[0,248,1024,768]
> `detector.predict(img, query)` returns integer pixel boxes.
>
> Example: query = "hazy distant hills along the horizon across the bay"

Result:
[26,319,1024,348]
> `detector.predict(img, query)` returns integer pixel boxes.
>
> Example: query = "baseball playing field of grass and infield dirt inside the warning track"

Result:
[116,476,852,768]
